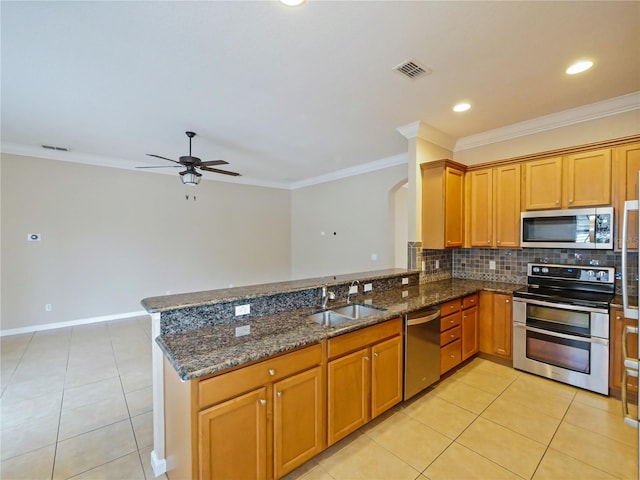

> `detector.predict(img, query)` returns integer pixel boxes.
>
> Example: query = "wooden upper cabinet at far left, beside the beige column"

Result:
[420,160,466,249]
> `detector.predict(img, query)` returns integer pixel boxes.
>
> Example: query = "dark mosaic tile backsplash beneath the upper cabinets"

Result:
[420,248,638,295]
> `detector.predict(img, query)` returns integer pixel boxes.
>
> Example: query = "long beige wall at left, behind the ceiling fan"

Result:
[0,155,291,331]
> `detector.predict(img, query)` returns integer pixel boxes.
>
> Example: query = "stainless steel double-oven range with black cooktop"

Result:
[513,263,615,395]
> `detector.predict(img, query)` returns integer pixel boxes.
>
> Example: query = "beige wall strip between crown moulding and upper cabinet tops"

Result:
[453,110,640,165]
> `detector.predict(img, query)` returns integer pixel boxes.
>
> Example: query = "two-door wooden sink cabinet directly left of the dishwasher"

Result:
[327,318,403,445]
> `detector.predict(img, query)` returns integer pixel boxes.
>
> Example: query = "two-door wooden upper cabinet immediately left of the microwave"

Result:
[466,164,520,248]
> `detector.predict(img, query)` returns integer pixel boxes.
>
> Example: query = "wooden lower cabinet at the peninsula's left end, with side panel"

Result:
[164,344,326,480]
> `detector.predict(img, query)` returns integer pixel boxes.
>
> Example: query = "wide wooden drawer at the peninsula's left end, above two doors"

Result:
[198,344,322,408]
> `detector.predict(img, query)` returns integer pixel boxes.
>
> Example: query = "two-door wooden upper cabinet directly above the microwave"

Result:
[524,148,611,210]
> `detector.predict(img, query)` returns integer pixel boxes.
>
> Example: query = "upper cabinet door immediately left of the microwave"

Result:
[493,165,520,248]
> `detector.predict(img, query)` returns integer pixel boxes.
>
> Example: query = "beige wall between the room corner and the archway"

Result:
[291,165,407,279]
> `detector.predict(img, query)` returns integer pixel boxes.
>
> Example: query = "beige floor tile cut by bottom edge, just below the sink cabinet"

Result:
[319,435,420,480]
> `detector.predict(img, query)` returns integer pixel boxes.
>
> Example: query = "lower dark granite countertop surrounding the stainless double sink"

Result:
[156,276,522,381]
